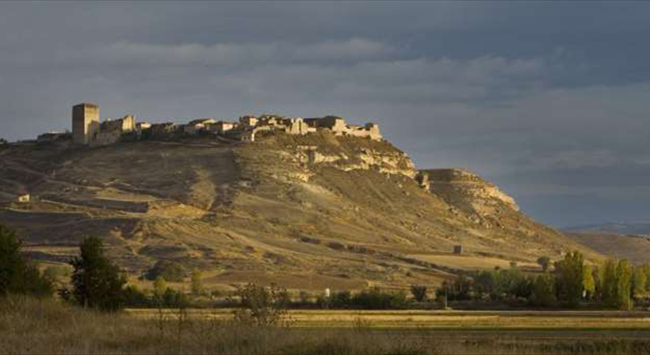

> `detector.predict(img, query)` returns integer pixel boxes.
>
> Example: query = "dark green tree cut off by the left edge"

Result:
[0,225,53,297]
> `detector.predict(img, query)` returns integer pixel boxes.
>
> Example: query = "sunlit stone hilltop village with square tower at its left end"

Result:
[38,103,382,146]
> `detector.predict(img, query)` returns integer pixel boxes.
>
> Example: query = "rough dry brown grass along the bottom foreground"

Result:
[0,297,650,355]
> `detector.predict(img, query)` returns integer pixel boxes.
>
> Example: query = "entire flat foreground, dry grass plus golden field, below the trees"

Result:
[0,297,650,355]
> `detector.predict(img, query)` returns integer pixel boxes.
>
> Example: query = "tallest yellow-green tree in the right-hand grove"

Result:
[555,251,584,307]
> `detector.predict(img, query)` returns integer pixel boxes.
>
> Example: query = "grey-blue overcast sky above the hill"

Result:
[0,1,650,226]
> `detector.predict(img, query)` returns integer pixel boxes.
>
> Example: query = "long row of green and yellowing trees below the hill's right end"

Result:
[436,252,650,310]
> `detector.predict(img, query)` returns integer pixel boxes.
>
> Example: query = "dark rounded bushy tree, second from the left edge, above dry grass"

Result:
[70,237,126,311]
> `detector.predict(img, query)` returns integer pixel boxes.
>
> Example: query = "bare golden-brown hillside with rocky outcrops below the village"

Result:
[0,131,600,289]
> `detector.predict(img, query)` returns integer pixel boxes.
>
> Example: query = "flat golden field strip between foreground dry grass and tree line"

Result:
[126,309,650,335]
